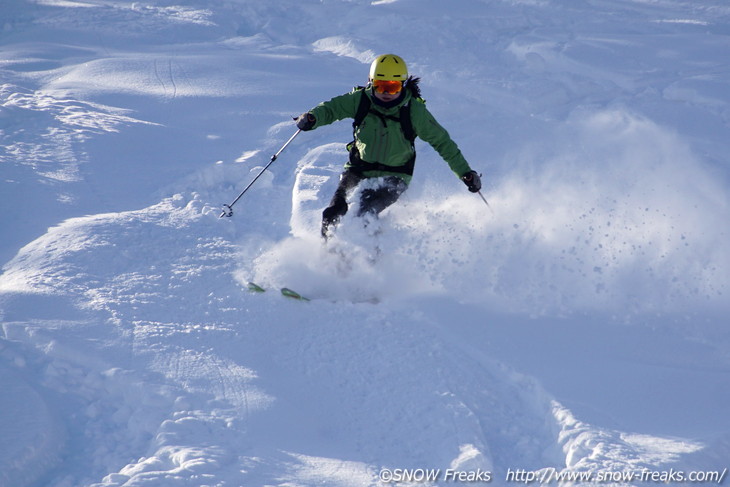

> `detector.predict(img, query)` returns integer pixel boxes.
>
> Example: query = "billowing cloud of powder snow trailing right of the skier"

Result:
[386,108,730,314]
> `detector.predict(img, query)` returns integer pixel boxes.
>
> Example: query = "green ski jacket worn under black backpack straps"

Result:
[310,88,471,183]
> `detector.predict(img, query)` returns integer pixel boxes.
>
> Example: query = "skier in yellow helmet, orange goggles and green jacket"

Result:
[296,54,481,239]
